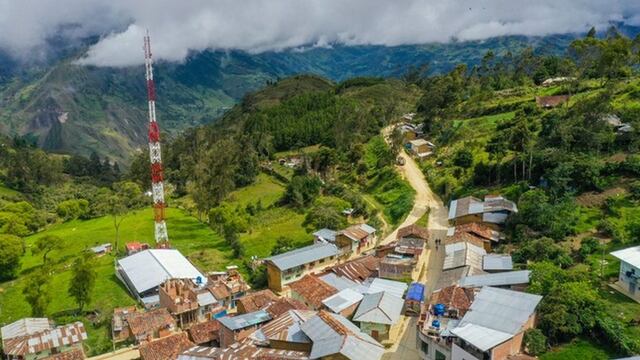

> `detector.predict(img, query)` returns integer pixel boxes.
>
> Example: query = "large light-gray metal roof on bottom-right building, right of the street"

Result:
[452,286,542,351]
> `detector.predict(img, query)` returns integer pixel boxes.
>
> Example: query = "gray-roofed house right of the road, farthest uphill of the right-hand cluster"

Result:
[449,195,518,230]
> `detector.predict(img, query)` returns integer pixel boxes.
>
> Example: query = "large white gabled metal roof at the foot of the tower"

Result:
[118,249,207,293]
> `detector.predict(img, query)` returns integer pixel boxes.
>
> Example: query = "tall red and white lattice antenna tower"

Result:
[144,30,169,248]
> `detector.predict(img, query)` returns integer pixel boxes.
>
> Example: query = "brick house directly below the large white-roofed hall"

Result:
[159,279,224,329]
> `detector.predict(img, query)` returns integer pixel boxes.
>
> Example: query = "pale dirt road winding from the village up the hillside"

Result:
[381,127,449,360]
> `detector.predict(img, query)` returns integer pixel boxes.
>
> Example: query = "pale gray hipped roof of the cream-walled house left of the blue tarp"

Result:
[353,292,404,325]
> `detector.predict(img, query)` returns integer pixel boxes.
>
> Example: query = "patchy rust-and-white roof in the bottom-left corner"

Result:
[3,321,87,357]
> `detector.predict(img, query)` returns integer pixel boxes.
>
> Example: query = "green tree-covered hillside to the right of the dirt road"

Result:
[402,29,640,359]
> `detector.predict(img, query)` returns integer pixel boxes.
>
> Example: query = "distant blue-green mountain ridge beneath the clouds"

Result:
[0,26,636,164]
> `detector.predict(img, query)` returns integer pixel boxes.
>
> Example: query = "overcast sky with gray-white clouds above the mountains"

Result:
[0,0,640,66]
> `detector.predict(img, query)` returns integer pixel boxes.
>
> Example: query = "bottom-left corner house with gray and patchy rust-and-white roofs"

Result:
[0,318,87,360]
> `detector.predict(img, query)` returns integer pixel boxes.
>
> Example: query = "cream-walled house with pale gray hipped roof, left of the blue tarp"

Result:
[353,292,404,344]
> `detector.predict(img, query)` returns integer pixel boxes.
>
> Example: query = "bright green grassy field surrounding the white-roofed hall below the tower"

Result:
[0,209,232,354]
